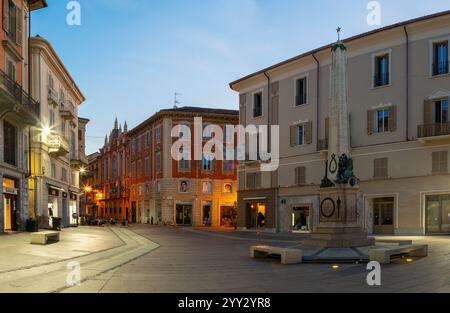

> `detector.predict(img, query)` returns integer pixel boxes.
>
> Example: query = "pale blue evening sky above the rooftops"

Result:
[32,0,450,153]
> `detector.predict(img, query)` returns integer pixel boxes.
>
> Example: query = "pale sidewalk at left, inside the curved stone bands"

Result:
[0,227,124,273]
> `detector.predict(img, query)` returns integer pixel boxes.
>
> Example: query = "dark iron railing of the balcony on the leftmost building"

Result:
[0,70,40,119]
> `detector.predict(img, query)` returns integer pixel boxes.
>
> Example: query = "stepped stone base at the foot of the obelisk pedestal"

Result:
[303,227,375,248]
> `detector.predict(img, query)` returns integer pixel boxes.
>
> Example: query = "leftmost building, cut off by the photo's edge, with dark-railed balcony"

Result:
[0,0,47,233]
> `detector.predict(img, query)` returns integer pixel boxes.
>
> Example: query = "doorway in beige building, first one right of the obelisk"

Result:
[372,197,395,235]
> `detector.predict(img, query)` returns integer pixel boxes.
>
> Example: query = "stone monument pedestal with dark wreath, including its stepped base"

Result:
[305,186,375,248]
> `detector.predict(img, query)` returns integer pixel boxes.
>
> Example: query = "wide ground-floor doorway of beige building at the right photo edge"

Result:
[425,195,450,235]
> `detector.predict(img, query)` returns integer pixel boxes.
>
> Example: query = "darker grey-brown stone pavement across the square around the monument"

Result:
[68,226,450,293]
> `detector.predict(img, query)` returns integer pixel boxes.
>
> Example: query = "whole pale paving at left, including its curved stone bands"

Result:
[0,227,159,293]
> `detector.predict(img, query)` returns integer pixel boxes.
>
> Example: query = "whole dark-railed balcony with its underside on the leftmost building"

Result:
[0,70,40,125]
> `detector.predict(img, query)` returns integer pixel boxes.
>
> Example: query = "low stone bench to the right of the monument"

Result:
[369,245,428,264]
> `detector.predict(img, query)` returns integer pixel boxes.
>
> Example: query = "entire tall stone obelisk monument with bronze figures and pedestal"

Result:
[308,28,374,248]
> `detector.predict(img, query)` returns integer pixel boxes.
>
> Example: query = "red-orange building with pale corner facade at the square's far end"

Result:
[98,107,239,227]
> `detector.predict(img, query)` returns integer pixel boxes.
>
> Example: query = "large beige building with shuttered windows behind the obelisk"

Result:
[230,12,450,235]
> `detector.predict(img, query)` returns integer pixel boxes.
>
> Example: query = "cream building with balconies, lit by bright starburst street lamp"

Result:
[29,36,89,227]
